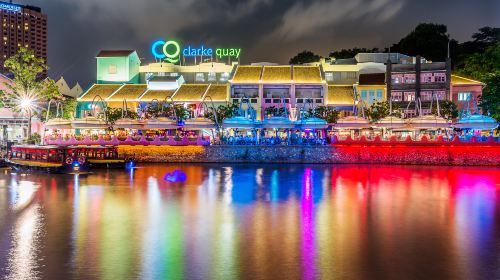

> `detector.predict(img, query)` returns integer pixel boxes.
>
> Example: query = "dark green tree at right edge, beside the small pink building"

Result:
[479,72,500,121]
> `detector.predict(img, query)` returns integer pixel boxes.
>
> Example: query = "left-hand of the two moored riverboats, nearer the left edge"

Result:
[5,145,89,173]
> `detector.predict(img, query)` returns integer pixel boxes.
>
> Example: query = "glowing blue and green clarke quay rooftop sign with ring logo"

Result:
[151,40,241,63]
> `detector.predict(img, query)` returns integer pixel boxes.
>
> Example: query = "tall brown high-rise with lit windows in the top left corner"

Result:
[0,2,47,73]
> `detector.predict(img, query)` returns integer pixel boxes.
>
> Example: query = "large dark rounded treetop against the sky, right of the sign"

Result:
[391,23,457,61]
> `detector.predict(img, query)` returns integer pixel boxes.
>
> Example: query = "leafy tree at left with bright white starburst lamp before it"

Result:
[2,48,48,139]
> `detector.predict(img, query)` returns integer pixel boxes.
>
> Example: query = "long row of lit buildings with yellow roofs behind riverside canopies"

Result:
[77,49,476,119]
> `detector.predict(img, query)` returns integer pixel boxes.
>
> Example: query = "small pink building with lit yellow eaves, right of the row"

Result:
[450,75,484,110]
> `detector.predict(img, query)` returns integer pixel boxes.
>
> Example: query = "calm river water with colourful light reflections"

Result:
[0,164,500,279]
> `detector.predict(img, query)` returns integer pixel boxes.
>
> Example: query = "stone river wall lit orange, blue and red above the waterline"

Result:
[118,144,500,166]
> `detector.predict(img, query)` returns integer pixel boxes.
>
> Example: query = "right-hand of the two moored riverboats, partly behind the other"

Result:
[68,145,137,169]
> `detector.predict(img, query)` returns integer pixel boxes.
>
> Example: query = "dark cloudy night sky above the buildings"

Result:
[14,0,500,89]
